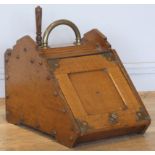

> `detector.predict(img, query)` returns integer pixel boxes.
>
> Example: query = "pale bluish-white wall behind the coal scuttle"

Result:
[0,5,155,97]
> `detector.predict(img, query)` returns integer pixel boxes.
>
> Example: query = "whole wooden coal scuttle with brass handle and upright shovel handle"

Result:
[5,7,150,147]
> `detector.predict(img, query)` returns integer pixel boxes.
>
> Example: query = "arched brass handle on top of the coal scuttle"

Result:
[42,19,81,48]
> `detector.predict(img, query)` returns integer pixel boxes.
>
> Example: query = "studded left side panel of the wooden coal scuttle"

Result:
[5,36,77,146]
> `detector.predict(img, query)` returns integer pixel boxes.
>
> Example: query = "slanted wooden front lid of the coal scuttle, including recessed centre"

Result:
[55,54,145,130]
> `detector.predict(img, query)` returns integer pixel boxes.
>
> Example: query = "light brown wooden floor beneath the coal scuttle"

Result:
[0,92,155,150]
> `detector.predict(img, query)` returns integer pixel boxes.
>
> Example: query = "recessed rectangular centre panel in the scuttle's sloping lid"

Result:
[69,68,125,115]
